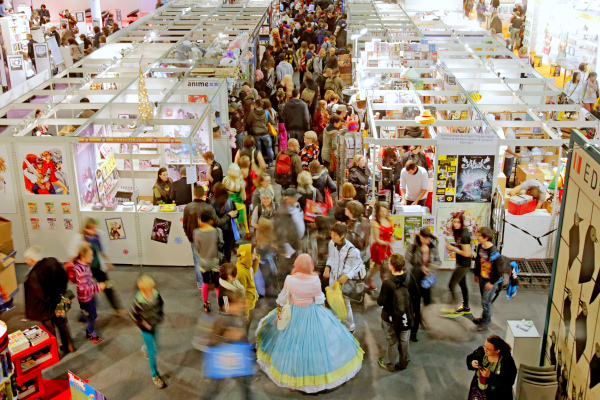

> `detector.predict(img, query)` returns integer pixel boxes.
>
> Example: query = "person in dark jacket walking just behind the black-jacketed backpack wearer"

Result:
[406,227,442,342]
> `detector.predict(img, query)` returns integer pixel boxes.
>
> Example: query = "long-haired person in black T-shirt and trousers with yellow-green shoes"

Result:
[442,212,471,316]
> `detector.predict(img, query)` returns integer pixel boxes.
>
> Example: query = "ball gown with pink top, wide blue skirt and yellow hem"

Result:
[256,273,364,393]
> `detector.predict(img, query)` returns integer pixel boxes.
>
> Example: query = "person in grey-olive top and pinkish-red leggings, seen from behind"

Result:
[194,212,225,313]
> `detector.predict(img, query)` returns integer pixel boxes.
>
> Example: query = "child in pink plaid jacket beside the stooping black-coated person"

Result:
[73,247,106,343]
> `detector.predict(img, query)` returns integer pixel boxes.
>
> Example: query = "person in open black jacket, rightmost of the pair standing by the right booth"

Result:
[473,226,502,330]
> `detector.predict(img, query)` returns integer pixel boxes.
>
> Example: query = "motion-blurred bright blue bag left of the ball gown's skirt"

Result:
[204,343,255,379]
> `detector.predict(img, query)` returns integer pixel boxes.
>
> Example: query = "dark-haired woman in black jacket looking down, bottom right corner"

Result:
[467,335,517,400]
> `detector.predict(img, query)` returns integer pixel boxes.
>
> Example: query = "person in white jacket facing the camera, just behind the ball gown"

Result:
[323,222,366,333]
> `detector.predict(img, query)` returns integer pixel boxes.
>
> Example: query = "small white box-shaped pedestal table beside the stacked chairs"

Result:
[504,321,542,370]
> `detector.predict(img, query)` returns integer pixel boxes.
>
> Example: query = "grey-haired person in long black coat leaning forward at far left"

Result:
[23,246,75,353]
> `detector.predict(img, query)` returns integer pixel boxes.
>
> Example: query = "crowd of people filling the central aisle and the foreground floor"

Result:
[17,0,516,399]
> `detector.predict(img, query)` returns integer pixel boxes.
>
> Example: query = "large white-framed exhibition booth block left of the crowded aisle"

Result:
[0,2,270,265]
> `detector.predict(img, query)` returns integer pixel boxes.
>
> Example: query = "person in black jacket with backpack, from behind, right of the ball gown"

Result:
[377,253,421,372]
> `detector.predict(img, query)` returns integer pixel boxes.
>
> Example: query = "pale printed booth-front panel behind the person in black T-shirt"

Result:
[437,203,490,261]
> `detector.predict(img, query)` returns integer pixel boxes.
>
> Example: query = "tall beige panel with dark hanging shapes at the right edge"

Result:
[542,134,600,399]
